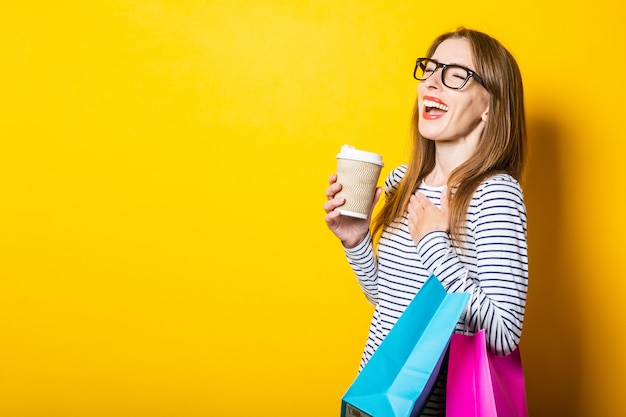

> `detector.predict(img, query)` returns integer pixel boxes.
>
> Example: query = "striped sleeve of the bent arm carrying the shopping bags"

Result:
[417,176,528,355]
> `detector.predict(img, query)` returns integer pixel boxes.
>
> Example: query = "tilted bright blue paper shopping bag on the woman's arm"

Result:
[341,275,469,417]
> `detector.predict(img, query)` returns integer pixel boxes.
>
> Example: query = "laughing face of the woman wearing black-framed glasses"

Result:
[417,38,489,150]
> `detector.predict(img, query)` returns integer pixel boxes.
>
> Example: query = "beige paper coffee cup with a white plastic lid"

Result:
[336,145,383,219]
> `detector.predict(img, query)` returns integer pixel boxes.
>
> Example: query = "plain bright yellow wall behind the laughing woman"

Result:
[0,0,626,417]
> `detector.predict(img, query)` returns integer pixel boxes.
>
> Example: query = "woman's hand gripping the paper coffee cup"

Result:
[324,174,383,248]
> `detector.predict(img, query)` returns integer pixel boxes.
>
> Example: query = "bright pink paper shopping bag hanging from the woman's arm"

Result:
[446,330,528,417]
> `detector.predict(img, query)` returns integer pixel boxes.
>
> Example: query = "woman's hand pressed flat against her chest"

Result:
[407,188,450,245]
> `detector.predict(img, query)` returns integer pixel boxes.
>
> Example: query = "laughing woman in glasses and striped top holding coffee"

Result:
[324,28,528,415]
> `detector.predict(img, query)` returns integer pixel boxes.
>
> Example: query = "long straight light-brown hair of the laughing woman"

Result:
[372,28,526,247]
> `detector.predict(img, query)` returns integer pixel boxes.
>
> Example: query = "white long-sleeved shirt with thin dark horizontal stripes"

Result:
[345,165,528,416]
